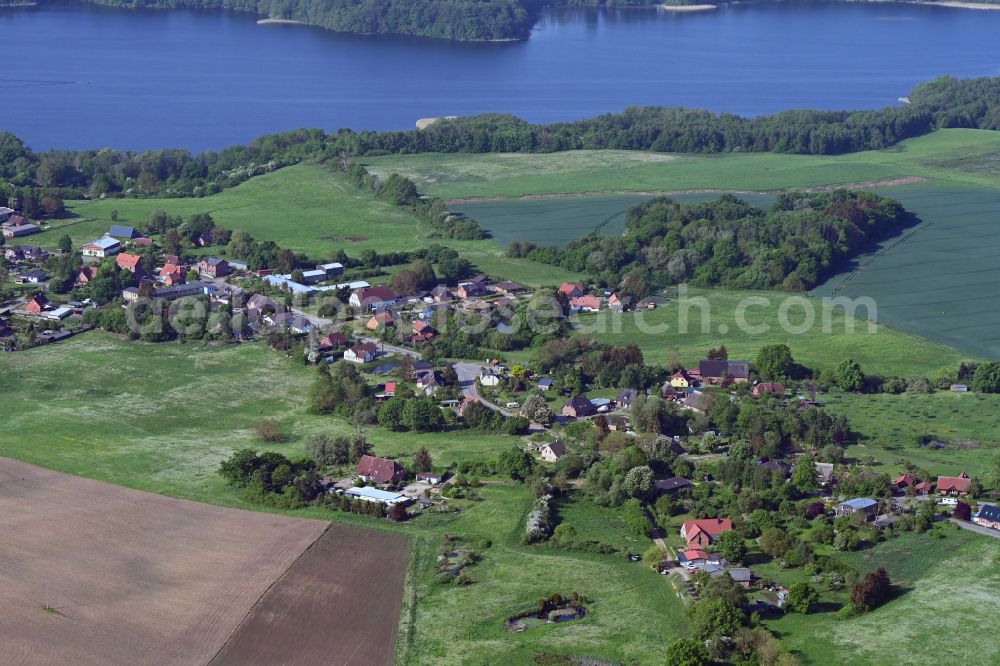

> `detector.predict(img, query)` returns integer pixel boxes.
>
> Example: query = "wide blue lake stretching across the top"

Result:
[0,2,1000,150]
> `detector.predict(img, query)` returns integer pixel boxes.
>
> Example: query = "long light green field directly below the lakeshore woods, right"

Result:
[363,129,1000,199]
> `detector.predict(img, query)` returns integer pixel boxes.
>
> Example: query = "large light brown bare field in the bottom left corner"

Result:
[0,458,328,666]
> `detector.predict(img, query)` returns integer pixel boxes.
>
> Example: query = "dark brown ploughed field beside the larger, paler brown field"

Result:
[212,525,406,666]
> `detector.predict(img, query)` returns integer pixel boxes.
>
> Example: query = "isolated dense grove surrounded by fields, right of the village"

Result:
[511,190,915,290]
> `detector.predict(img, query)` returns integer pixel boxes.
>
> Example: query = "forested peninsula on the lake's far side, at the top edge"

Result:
[68,0,538,41]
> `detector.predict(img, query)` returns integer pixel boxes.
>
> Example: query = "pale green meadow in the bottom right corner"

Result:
[766,525,1000,666]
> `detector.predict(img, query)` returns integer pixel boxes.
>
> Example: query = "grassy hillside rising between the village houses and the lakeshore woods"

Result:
[17,164,578,285]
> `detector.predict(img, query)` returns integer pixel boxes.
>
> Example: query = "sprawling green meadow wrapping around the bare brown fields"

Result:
[0,333,685,664]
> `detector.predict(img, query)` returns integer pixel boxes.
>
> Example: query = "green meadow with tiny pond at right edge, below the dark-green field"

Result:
[823,391,1000,477]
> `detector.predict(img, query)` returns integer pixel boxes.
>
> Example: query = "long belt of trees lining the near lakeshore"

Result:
[0,77,1000,207]
